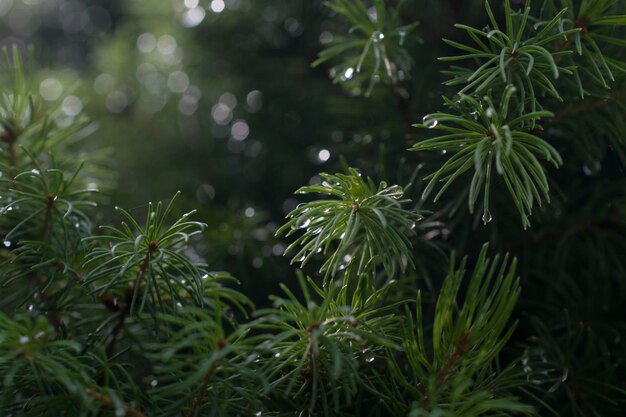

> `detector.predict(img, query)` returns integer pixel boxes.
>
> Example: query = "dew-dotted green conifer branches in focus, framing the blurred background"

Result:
[0,0,626,417]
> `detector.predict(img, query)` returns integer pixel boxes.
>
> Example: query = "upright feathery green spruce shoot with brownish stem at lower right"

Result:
[391,245,533,416]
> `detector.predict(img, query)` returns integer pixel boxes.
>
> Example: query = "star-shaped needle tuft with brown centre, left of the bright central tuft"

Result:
[83,193,206,314]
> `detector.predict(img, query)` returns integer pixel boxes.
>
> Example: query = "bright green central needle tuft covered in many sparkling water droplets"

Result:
[277,169,421,276]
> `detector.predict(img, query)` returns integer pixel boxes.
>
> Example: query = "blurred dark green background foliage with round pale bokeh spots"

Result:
[0,0,482,303]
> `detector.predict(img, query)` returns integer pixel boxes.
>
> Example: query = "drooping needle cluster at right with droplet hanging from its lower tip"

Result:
[411,85,563,227]
